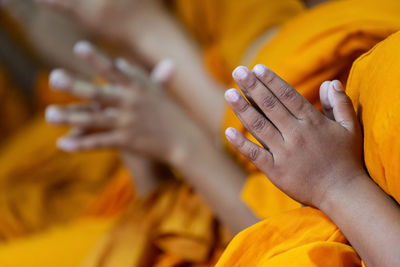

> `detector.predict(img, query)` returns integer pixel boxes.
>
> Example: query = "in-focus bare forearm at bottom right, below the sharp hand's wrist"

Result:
[321,175,400,266]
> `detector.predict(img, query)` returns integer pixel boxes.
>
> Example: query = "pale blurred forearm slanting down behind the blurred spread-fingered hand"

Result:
[124,12,225,137]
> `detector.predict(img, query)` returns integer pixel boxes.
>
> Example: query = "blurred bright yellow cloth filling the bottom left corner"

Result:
[0,218,113,267]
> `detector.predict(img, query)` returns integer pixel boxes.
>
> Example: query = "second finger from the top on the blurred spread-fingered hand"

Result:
[50,70,127,105]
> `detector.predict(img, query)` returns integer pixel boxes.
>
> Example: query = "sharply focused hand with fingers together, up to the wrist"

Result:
[225,65,365,207]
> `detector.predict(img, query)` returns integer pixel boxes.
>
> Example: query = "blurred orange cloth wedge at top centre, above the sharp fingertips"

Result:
[173,0,304,83]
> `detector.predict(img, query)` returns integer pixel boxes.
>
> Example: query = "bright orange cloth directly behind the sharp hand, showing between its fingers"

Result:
[224,0,400,218]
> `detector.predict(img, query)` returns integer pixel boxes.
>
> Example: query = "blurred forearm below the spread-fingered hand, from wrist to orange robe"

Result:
[173,126,259,233]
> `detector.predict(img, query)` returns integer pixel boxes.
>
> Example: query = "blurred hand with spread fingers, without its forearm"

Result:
[46,43,190,163]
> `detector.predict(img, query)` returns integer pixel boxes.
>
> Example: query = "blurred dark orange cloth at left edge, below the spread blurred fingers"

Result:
[0,118,118,240]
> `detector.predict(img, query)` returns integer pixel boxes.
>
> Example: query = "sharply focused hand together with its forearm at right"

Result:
[225,65,400,266]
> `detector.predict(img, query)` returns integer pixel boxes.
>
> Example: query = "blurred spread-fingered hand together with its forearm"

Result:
[46,45,258,233]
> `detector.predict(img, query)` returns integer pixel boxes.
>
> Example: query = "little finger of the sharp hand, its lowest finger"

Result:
[225,128,274,173]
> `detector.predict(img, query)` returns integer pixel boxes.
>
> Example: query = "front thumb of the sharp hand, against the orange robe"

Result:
[328,80,358,132]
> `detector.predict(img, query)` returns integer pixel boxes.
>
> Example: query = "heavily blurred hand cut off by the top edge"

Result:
[36,0,163,40]
